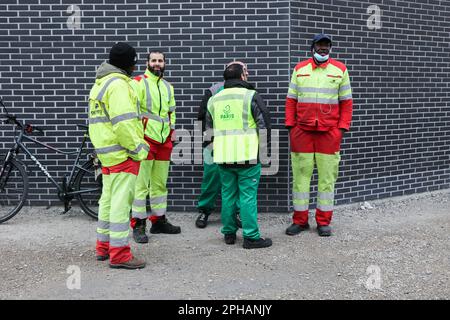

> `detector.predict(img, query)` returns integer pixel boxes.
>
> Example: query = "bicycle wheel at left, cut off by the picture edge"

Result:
[0,159,28,223]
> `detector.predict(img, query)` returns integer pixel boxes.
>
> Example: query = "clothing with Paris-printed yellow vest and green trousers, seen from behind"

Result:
[206,80,270,240]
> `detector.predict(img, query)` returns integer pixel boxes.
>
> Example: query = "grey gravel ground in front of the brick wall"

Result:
[0,190,450,300]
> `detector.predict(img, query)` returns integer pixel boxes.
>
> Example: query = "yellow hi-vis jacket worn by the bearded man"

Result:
[133,70,175,143]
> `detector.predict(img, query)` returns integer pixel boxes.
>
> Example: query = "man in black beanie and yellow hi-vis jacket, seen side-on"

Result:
[89,42,149,269]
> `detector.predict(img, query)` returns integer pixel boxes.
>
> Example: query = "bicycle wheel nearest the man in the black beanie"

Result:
[74,159,102,219]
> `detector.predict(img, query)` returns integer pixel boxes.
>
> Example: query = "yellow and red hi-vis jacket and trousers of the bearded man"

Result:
[131,70,176,227]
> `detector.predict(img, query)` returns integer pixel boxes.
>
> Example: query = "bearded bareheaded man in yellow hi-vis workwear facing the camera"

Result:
[131,51,181,243]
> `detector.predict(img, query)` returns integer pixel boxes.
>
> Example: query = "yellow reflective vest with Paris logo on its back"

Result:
[208,88,259,163]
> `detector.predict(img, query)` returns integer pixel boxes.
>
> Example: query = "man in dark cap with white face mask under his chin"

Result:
[285,34,353,236]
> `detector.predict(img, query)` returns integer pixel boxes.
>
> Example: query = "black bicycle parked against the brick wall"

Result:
[0,98,102,223]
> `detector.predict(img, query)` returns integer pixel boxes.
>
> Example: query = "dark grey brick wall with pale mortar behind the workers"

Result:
[0,0,450,212]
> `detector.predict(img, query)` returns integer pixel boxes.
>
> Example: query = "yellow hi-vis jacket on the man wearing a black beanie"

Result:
[89,73,149,167]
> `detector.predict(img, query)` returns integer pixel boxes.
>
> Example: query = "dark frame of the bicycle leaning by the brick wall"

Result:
[0,125,92,195]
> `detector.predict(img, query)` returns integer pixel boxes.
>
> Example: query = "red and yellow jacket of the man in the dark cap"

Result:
[285,58,353,131]
